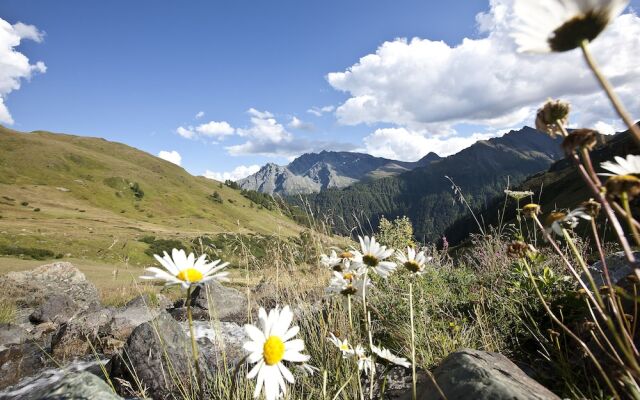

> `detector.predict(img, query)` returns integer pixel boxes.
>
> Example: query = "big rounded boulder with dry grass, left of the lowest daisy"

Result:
[109,312,214,399]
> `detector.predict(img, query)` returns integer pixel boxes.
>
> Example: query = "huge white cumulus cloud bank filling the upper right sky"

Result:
[327,0,640,133]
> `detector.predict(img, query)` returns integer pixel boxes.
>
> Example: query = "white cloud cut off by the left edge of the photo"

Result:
[0,18,47,124]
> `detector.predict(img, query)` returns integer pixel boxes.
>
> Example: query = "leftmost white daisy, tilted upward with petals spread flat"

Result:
[140,249,229,289]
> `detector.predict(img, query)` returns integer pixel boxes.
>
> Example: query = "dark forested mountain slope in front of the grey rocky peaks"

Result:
[292,127,561,241]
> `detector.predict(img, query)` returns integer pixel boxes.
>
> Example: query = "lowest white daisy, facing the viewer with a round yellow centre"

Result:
[243,306,310,400]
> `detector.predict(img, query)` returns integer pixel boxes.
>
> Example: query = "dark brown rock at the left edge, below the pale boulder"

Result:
[0,342,47,389]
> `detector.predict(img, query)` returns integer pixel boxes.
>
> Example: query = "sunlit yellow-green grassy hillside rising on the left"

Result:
[0,127,302,272]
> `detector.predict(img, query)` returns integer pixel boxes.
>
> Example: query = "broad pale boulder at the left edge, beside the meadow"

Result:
[0,262,100,310]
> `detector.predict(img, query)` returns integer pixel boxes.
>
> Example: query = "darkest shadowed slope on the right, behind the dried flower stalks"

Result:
[445,126,640,244]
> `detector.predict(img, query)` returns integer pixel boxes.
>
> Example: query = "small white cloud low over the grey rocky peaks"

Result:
[226,108,355,158]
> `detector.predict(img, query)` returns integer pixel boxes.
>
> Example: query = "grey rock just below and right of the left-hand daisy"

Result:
[191,281,247,322]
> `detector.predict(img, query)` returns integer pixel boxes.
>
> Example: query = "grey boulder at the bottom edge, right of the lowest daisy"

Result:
[410,349,560,400]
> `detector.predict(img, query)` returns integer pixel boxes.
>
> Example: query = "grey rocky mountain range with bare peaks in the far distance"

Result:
[238,151,440,195]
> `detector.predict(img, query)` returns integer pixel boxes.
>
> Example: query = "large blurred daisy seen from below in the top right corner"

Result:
[513,0,629,53]
